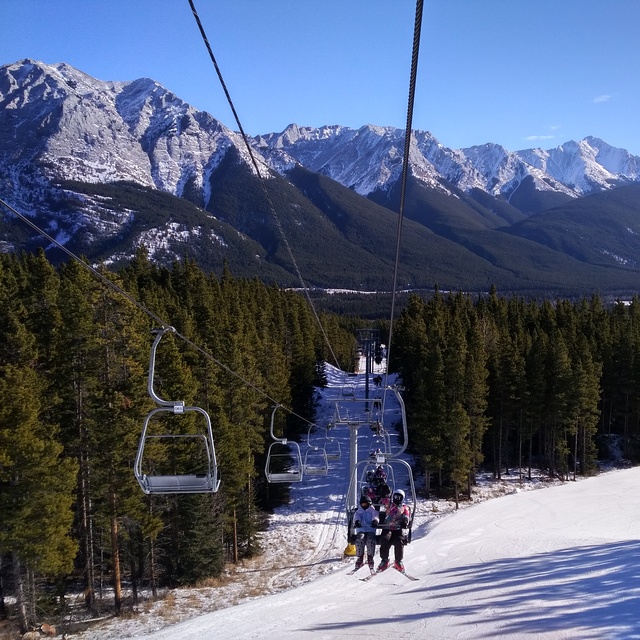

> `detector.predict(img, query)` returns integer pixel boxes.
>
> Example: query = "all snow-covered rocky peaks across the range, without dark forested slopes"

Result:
[0,60,640,212]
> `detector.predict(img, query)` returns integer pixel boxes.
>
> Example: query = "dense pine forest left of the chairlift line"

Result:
[0,248,356,627]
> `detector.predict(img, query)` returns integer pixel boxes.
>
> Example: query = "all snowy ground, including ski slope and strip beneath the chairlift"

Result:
[74,367,640,640]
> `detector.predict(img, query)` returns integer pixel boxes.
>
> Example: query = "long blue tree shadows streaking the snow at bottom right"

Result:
[304,540,640,640]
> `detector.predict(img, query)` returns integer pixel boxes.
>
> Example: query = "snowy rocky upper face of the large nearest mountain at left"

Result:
[0,60,272,204]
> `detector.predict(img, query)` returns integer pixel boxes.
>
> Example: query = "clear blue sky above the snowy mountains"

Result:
[0,0,640,155]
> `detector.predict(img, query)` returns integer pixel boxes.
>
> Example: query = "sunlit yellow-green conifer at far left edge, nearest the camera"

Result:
[0,270,77,632]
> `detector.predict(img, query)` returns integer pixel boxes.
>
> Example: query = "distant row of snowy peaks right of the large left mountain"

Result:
[257,124,640,200]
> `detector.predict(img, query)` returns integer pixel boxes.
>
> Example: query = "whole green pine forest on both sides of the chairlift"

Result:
[0,250,640,630]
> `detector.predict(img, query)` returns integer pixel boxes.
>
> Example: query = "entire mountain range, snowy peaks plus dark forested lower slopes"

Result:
[0,60,640,296]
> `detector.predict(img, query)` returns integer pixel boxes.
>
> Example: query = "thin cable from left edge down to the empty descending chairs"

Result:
[0,192,315,425]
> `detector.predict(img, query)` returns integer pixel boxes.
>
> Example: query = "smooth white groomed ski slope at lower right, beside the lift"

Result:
[136,468,640,640]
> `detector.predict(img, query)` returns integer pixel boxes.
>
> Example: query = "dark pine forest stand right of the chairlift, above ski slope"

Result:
[391,290,640,502]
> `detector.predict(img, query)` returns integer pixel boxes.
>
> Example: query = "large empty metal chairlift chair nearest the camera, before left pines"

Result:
[133,327,220,494]
